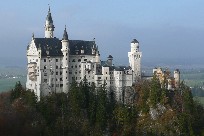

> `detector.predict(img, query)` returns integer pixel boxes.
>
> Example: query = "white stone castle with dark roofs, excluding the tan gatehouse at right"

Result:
[26,8,142,100]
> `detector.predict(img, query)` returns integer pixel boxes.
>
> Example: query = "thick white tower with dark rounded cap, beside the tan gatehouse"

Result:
[128,39,142,82]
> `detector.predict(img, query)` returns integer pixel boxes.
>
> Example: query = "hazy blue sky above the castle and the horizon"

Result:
[0,0,204,66]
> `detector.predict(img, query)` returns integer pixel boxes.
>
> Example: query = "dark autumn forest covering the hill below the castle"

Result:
[0,76,204,136]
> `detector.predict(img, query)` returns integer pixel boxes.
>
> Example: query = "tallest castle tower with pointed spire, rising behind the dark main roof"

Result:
[45,7,55,38]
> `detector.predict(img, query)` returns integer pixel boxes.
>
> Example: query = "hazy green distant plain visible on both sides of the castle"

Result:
[0,67,204,105]
